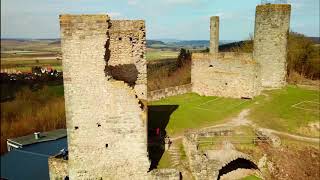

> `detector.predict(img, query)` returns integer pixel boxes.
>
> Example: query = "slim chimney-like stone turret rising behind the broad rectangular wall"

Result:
[210,16,219,54]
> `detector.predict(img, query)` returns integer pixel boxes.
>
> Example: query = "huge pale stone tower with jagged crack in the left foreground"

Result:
[60,15,150,179]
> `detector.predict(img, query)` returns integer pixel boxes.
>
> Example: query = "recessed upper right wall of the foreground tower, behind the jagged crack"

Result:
[108,20,147,99]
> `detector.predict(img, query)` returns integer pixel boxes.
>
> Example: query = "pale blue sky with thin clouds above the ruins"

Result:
[1,0,319,40]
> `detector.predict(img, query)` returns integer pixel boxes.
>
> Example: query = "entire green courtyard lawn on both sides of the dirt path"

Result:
[150,85,320,137]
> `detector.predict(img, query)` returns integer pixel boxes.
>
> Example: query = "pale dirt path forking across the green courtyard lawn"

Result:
[170,109,320,143]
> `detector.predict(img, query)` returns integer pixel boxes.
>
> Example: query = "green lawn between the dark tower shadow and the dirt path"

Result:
[150,93,253,135]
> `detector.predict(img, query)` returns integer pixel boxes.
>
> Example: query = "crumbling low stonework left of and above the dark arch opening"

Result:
[182,128,253,180]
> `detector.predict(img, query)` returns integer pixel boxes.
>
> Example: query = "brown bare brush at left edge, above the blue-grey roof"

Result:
[1,87,66,154]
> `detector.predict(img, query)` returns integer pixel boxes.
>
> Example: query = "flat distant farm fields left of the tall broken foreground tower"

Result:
[1,39,62,72]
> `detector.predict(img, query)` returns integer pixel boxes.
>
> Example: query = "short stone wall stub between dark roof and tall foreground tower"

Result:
[48,157,68,180]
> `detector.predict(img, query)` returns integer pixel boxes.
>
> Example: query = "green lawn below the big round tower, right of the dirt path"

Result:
[250,86,320,136]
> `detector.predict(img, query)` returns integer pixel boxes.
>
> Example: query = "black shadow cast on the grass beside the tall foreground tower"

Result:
[148,105,179,170]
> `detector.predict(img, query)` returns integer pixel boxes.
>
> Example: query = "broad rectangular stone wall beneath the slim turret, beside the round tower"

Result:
[191,53,261,98]
